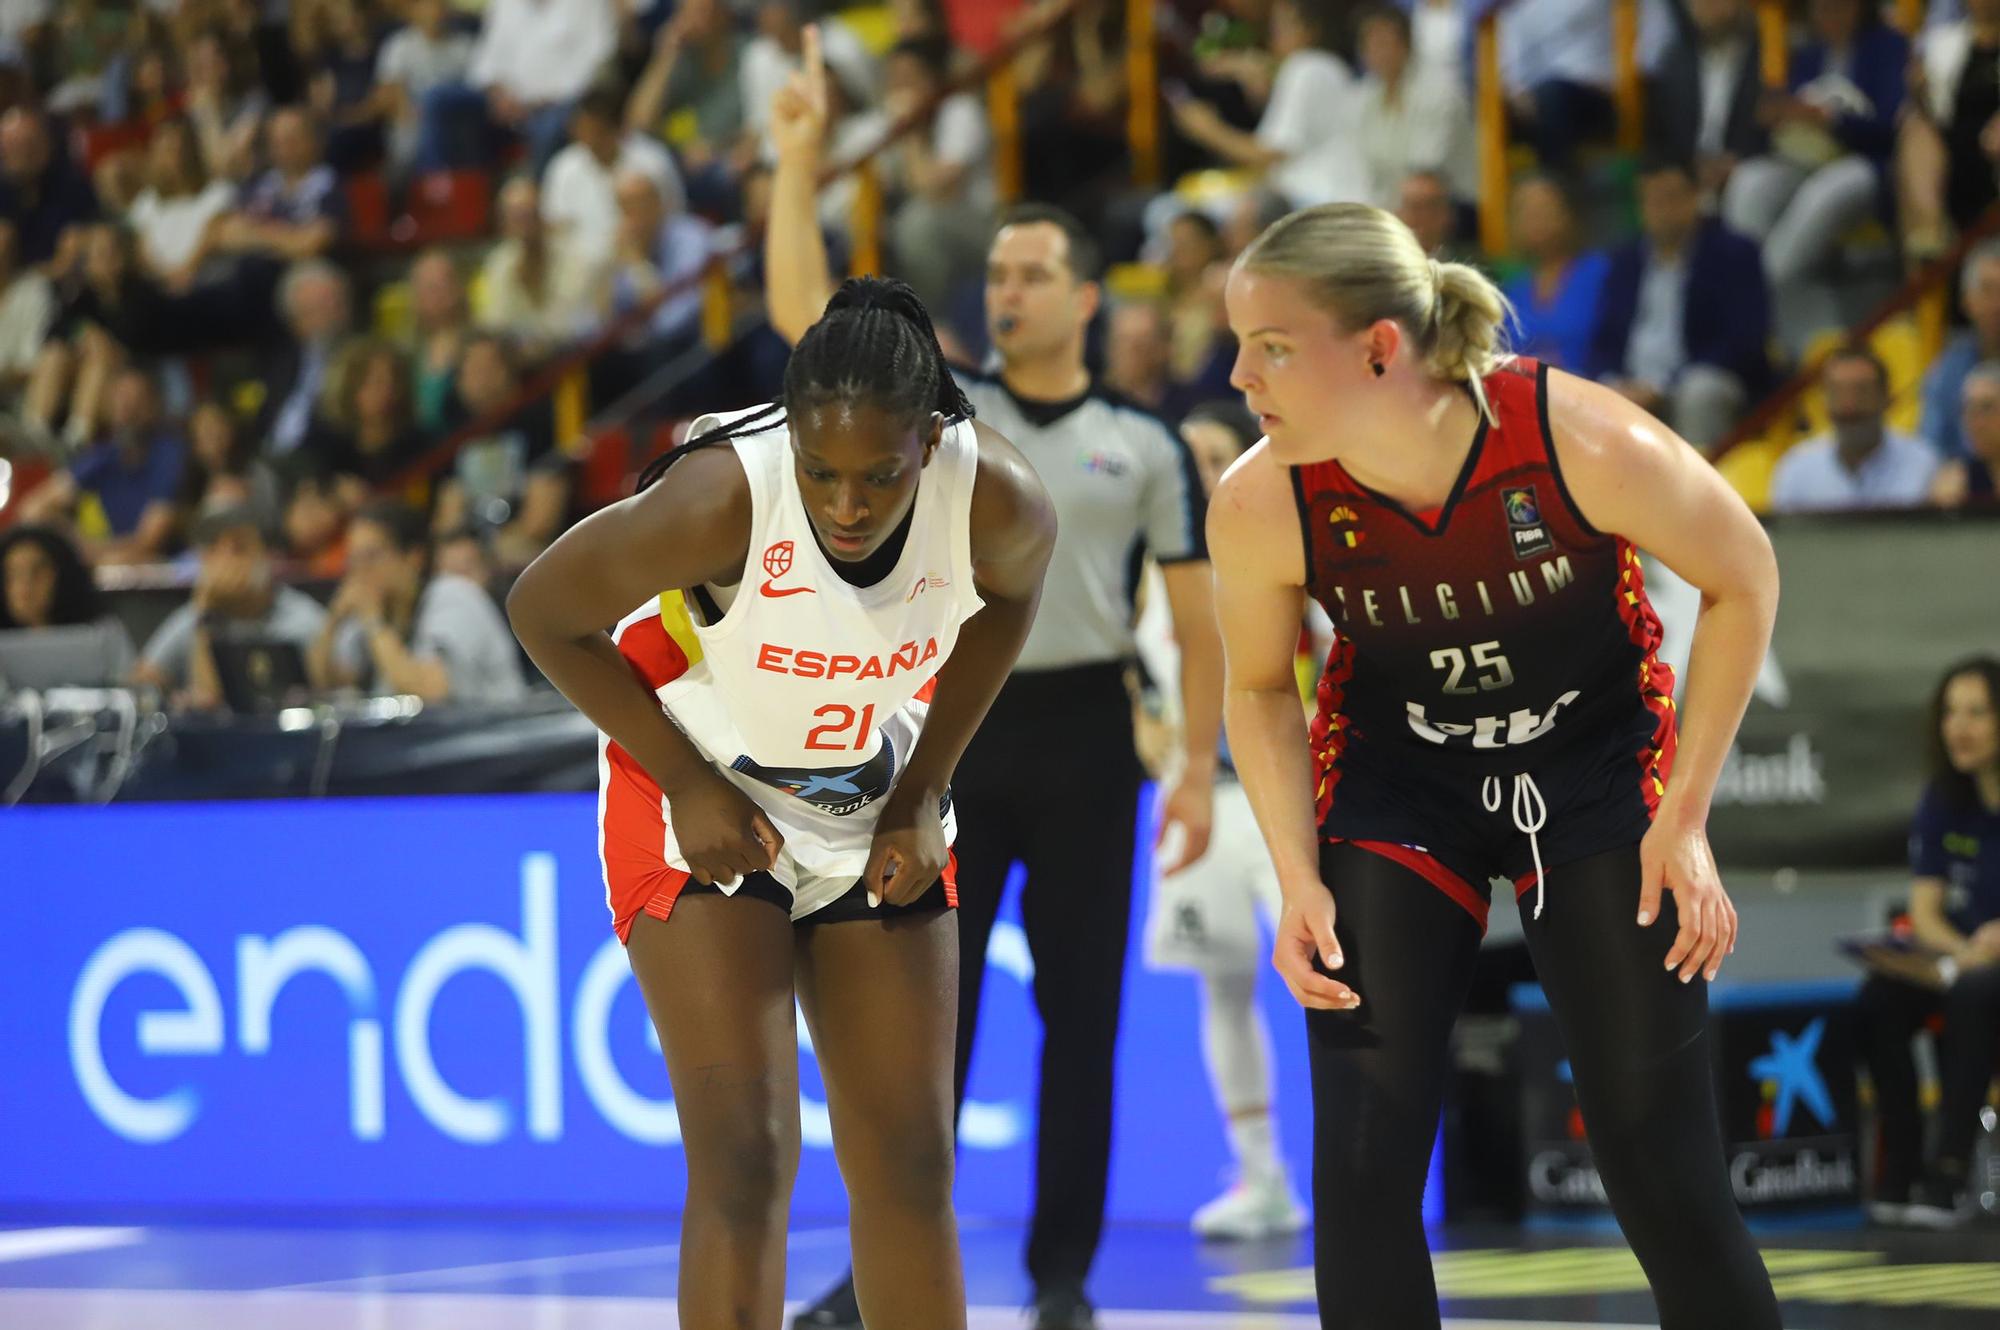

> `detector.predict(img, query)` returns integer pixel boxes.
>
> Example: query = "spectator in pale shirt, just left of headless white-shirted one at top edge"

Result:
[376,0,484,176]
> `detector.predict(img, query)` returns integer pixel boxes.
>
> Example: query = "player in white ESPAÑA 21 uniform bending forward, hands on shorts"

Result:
[508,278,1054,1330]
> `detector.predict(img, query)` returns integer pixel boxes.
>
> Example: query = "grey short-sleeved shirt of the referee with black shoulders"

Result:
[956,370,1208,670]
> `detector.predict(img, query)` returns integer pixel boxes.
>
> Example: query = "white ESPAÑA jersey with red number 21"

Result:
[600,412,982,918]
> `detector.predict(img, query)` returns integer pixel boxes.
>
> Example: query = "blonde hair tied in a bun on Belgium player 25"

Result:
[1236,204,1512,420]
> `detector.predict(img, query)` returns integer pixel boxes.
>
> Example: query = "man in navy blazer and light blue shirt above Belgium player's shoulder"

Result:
[1590,162,1770,448]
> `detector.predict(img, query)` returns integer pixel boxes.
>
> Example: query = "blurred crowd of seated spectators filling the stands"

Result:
[0,0,2000,716]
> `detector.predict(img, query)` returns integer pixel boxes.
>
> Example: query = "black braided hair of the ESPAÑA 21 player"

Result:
[636,278,972,490]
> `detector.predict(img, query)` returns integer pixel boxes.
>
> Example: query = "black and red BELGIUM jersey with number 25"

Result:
[1292,358,1674,822]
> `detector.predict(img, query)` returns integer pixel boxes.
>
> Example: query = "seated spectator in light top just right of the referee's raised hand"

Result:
[882,38,996,310]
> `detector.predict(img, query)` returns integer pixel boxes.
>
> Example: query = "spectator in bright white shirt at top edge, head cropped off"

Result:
[472,0,618,170]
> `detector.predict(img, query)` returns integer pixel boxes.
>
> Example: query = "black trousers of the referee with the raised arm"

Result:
[952,664,1142,1290]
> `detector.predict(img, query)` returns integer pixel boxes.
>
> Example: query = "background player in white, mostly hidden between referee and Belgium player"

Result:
[1134,402,1332,1240]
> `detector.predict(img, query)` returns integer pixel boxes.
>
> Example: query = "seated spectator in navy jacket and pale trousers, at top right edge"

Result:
[1722,0,1910,296]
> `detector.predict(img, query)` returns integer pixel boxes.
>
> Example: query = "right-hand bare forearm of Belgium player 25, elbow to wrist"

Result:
[1660,584,1778,826]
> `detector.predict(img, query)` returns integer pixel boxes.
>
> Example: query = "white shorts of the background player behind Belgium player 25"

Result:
[1146,780,1282,974]
